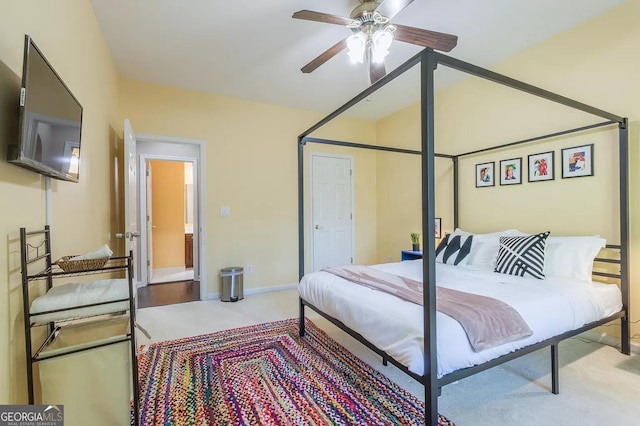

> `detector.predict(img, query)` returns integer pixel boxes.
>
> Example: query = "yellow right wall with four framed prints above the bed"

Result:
[378,1,640,341]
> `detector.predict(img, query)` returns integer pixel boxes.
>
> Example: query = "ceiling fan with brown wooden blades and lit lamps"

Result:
[293,0,458,84]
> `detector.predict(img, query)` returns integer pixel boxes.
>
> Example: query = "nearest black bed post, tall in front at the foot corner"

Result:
[421,49,438,426]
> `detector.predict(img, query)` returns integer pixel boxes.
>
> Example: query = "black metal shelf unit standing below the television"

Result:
[20,225,140,424]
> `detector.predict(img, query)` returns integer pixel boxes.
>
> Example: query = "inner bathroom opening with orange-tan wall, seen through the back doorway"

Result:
[146,159,194,284]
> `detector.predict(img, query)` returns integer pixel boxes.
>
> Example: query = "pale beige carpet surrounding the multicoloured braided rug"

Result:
[138,290,640,426]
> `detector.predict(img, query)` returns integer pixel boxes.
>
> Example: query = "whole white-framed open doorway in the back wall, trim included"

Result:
[136,133,208,306]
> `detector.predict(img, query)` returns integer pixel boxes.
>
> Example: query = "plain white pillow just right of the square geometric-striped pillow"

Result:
[544,236,607,282]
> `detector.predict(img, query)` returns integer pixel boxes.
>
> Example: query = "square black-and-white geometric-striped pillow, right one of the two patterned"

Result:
[495,231,550,280]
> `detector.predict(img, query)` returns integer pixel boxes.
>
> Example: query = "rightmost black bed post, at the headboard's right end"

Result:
[618,117,631,355]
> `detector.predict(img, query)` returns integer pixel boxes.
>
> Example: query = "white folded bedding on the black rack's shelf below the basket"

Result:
[30,278,129,323]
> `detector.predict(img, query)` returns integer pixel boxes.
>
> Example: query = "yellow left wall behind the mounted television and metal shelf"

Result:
[0,0,118,410]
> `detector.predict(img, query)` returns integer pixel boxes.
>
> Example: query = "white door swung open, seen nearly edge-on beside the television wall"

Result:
[123,119,140,277]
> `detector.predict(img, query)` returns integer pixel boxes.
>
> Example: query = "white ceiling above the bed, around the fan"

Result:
[91,0,624,119]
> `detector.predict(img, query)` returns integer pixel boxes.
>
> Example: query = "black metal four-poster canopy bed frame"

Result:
[298,49,631,425]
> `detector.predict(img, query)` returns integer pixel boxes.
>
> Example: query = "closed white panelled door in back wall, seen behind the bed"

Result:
[311,154,353,271]
